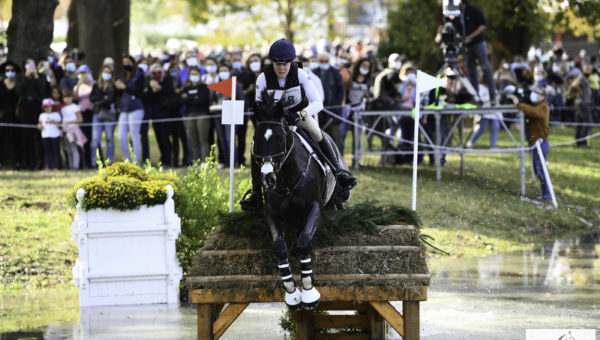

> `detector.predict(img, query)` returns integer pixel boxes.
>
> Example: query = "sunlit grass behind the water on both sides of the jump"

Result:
[0,128,600,332]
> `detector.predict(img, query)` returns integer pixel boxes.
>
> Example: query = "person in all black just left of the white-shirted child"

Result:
[16,58,48,170]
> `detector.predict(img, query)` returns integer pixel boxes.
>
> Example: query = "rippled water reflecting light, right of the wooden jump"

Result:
[418,234,600,340]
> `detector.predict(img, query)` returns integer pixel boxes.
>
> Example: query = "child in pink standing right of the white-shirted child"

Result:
[60,90,87,170]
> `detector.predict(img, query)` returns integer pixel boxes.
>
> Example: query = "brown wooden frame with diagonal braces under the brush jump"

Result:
[188,286,427,340]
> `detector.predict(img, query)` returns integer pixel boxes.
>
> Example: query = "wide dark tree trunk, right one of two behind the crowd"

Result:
[67,0,130,76]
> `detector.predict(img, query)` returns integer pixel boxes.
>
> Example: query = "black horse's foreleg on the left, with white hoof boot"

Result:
[267,216,302,310]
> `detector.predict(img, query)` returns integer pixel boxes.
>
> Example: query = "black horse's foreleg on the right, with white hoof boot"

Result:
[297,202,321,309]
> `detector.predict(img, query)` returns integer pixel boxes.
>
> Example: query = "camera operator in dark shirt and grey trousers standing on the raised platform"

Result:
[460,0,496,105]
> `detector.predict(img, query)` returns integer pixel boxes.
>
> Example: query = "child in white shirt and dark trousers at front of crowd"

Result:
[38,98,61,171]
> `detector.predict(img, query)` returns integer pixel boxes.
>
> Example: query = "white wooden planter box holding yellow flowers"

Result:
[71,185,182,306]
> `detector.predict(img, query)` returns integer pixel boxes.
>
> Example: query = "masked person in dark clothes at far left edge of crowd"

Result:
[0,60,22,168]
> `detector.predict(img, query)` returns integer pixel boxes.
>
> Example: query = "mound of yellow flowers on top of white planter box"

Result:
[69,162,179,211]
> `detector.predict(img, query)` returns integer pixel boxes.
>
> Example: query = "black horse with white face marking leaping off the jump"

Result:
[252,92,349,310]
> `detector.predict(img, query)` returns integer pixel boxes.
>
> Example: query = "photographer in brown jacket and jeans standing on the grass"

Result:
[508,87,551,201]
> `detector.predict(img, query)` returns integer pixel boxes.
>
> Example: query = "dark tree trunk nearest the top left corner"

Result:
[7,0,58,64]
